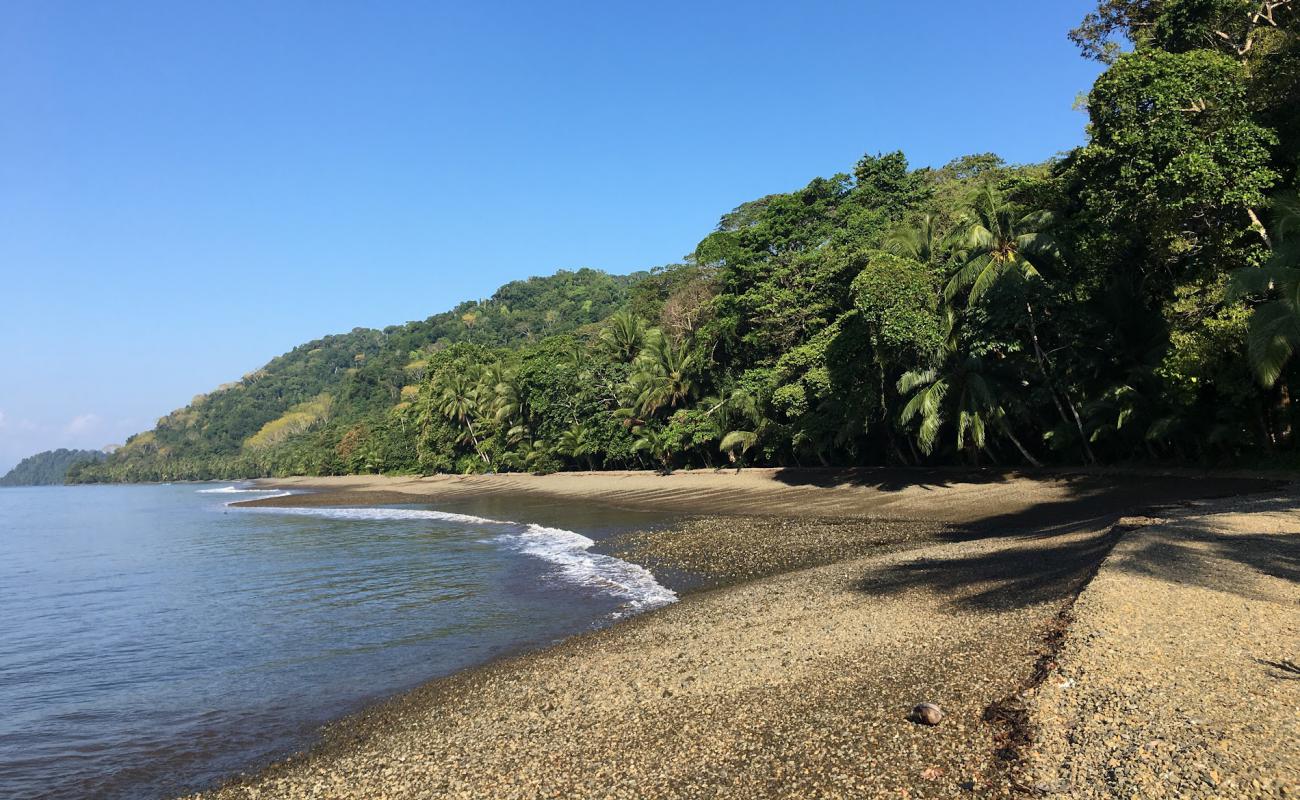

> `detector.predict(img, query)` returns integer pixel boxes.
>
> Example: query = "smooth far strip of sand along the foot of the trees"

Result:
[245,468,1268,533]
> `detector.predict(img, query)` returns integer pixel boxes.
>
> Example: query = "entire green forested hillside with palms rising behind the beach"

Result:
[70,0,1300,481]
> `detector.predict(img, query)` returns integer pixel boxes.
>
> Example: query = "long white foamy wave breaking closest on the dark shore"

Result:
[235,507,677,617]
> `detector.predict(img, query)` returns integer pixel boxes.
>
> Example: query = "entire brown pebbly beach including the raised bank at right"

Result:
[188,470,1300,799]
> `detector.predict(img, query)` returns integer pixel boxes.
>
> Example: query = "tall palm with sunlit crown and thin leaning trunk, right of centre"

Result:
[944,186,1096,463]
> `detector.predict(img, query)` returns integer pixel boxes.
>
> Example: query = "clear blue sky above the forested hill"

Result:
[0,0,1097,471]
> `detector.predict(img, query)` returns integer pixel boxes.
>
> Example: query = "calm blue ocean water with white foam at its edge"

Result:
[0,484,675,799]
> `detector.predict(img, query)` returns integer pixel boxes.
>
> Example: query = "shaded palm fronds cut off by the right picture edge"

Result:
[1231,191,1300,386]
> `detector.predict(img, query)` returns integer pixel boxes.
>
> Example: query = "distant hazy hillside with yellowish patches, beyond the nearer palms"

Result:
[78,269,636,480]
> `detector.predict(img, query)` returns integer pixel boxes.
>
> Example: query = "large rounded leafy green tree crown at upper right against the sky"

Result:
[1075,51,1278,276]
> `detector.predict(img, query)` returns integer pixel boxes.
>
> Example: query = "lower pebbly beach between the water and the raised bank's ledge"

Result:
[195,471,1300,799]
